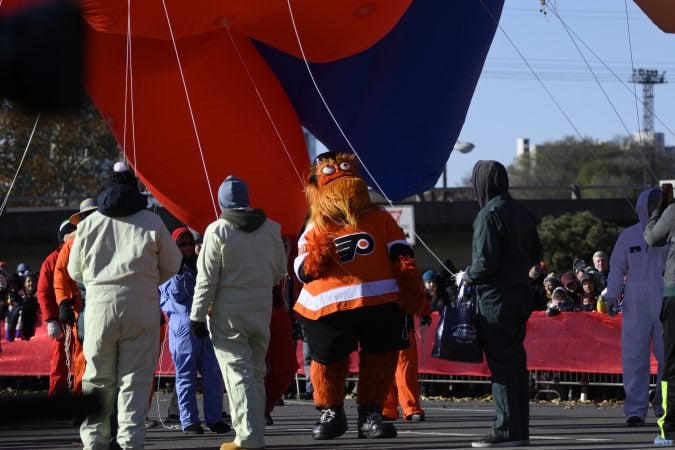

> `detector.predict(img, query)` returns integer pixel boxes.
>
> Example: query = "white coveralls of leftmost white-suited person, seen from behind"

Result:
[68,210,181,450]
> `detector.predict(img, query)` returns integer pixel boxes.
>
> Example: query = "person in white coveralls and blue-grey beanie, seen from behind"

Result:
[190,176,286,450]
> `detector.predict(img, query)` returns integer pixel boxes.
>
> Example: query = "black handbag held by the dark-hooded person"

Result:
[431,281,483,364]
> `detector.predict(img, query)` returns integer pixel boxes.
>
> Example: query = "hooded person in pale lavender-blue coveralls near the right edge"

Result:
[606,189,668,420]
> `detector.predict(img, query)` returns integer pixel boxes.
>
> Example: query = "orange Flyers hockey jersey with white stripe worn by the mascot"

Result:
[293,209,408,319]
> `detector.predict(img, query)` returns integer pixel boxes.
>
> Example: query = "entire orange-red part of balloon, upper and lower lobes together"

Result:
[81,0,410,235]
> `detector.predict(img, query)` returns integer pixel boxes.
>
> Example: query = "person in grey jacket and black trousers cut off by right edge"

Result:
[644,186,675,445]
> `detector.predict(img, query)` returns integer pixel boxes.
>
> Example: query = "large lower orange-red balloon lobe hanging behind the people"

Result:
[86,24,309,235]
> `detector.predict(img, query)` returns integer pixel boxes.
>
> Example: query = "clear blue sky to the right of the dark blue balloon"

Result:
[448,0,675,186]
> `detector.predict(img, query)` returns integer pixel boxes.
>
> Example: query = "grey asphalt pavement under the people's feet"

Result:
[0,393,658,450]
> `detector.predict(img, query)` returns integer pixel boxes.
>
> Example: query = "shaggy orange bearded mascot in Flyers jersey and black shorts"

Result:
[294,152,425,439]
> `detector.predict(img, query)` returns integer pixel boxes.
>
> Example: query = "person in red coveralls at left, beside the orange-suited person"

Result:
[37,220,76,397]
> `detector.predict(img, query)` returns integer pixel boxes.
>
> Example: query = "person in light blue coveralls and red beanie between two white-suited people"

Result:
[159,228,230,434]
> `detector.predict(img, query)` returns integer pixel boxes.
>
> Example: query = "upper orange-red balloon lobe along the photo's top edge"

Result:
[80,0,412,62]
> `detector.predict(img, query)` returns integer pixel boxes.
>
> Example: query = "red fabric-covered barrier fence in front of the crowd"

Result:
[0,312,657,376]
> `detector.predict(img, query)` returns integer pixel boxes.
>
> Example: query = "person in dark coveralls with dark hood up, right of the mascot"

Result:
[458,161,543,448]
